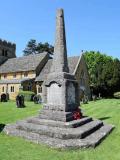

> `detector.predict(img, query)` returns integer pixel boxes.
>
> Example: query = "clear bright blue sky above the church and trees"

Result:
[0,0,120,58]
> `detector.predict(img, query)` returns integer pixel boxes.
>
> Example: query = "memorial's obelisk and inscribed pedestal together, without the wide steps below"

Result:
[43,9,79,121]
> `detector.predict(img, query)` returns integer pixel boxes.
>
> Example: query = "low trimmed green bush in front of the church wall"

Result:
[18,91,35,101]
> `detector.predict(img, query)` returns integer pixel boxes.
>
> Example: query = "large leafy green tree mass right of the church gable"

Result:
[84,51,120,97]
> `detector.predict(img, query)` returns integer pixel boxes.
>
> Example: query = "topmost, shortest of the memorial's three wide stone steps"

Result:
[26,117,92,128]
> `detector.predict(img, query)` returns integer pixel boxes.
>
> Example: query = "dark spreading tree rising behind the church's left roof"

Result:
[23,39,54,56]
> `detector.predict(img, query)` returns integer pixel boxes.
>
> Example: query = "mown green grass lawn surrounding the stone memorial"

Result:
[0,99,120,160]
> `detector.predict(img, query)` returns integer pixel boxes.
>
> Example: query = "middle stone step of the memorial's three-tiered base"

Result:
[17,120,103,139]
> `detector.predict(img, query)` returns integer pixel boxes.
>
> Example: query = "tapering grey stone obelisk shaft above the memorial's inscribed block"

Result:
[53,9,69,72]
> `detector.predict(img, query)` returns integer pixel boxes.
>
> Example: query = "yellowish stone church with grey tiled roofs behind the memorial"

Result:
[0,40,90,100]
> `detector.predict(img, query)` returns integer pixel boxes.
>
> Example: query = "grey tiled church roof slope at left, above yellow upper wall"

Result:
[0,52,48,73]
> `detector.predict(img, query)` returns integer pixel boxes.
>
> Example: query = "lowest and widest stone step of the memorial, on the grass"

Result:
[4,124,114,149]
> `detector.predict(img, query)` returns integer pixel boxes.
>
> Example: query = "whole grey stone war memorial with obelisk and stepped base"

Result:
[4,9,114,148]
